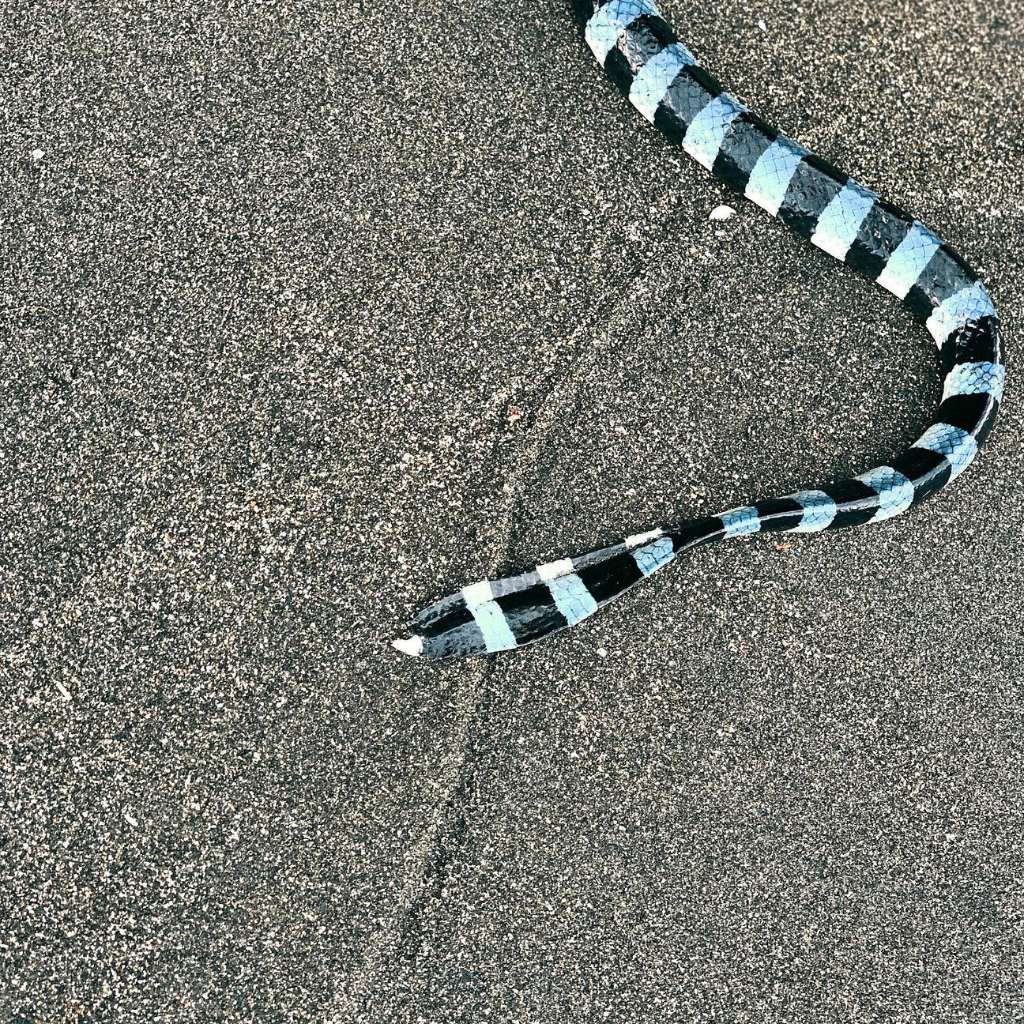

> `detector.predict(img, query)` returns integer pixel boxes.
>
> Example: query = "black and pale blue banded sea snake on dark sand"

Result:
[392,0,1006,659]
